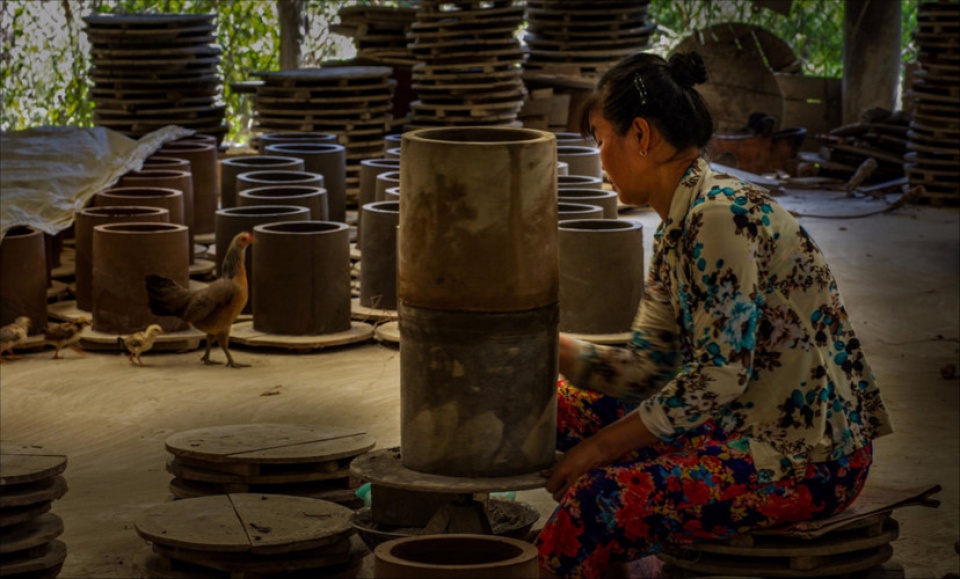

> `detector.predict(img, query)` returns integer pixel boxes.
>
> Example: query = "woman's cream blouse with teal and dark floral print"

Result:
[567,159,892,480]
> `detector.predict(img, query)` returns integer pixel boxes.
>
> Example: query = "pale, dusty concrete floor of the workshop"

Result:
[0,192,960,578]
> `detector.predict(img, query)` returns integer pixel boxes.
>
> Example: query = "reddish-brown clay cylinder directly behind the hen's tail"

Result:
[93,223,190,334]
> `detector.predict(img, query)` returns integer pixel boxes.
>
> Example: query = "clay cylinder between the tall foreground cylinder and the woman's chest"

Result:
[560,219,644,334]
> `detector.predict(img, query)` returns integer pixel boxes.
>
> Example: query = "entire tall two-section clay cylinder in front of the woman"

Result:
[397,127,559,477]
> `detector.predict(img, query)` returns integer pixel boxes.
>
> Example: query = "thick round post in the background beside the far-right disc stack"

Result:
[843,0,901,124]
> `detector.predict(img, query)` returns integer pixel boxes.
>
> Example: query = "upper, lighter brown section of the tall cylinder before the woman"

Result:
[397,127,559,312]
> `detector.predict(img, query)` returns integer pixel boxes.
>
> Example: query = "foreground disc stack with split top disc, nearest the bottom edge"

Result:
[134,493,368,579]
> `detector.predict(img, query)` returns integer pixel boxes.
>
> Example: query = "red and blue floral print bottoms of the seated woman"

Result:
[537,381,872,577]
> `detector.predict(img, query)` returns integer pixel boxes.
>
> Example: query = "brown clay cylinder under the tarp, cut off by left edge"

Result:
[0,226,47,334]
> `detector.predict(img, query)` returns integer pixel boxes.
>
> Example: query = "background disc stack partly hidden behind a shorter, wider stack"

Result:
[330,6,416,65]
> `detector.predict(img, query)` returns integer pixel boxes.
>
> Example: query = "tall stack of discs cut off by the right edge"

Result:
[904,2,960,204]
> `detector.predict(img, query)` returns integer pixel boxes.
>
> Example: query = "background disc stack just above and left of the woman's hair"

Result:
[524,0,655,77]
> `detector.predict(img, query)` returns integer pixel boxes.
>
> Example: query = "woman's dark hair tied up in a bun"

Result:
[580,52,713,151]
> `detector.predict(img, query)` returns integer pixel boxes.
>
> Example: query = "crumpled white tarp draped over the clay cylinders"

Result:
[0,125,194,240]
